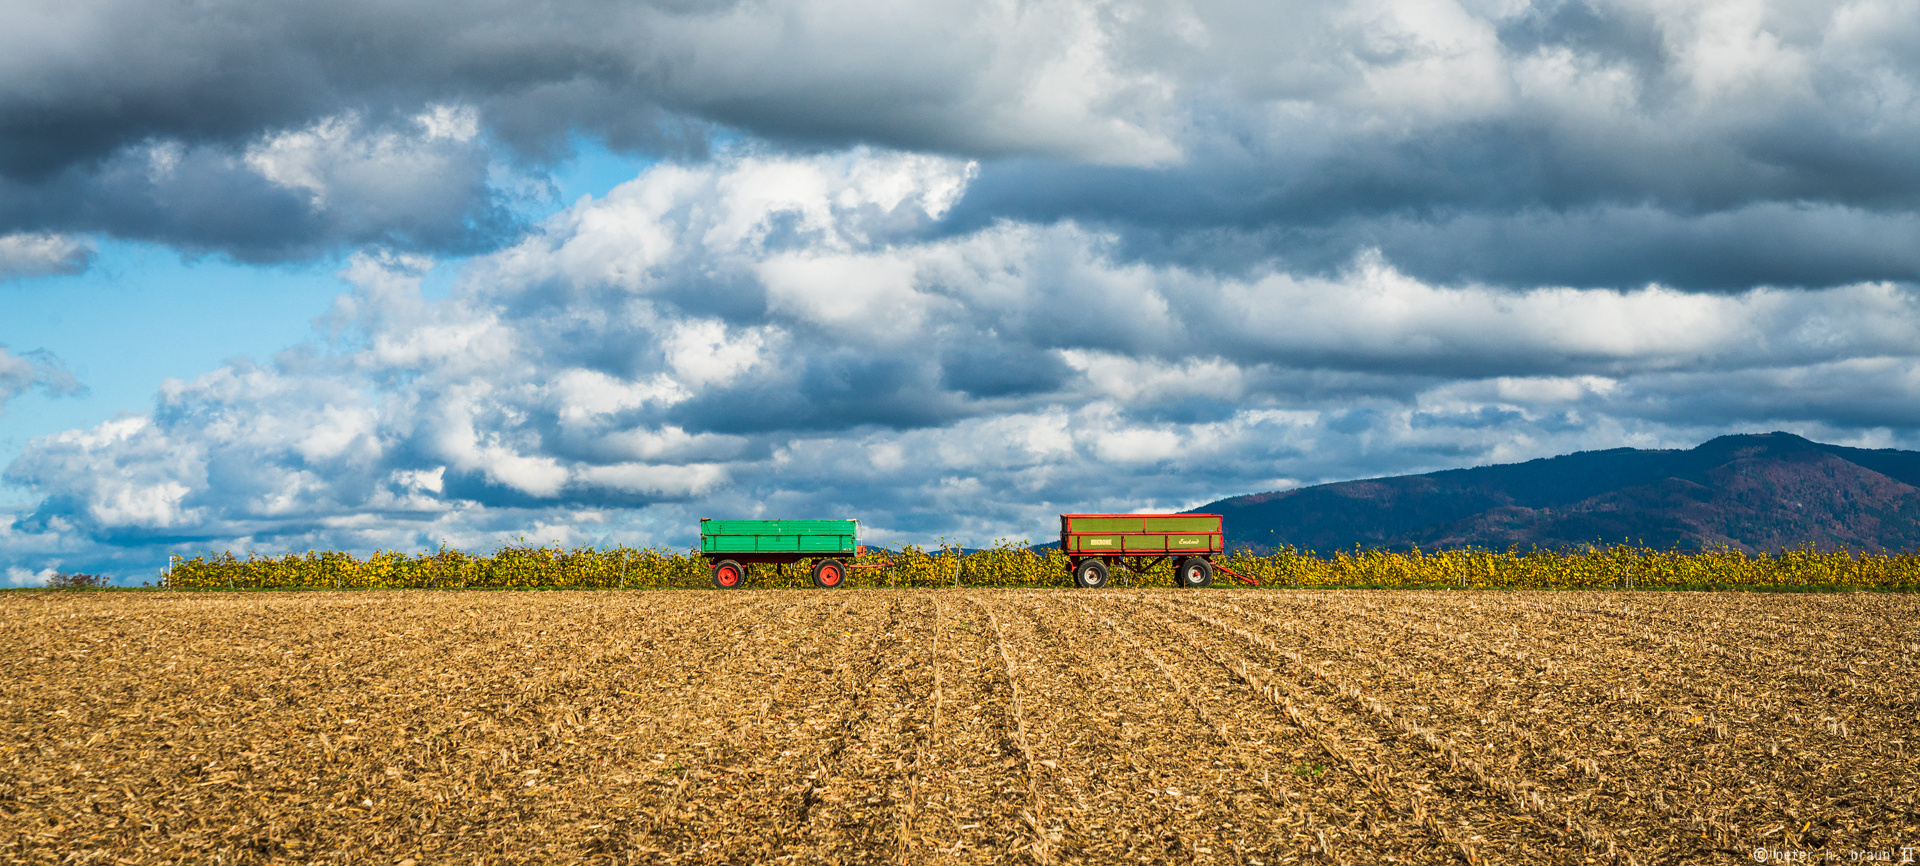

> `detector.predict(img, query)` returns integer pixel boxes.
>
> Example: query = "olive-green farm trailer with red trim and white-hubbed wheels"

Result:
[1060,515,1227,588]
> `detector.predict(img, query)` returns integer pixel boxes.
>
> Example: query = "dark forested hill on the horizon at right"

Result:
[1192,432,1920,553]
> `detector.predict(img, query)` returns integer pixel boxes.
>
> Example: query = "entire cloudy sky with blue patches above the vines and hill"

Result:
[0,0,1920,586]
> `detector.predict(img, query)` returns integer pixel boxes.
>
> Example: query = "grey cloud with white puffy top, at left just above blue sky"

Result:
[0,106,516,261]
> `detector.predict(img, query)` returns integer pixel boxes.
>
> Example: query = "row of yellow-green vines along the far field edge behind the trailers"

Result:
[161,541,1920,589]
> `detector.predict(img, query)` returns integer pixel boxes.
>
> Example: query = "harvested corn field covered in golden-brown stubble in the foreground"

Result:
[0,589,1920,866]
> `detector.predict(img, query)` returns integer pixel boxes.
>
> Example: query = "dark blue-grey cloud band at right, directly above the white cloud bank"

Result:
[948,141,1920,292]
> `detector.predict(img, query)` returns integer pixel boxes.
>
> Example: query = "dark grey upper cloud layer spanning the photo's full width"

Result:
[0,0,1920,284]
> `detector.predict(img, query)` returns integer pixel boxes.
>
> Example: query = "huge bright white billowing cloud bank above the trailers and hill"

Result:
[11,146,1920,583]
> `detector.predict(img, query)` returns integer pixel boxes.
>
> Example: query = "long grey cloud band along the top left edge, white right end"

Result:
[0,0,1167,177]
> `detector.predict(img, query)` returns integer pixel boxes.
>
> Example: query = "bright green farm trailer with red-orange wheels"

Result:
[701,517,864,589]
